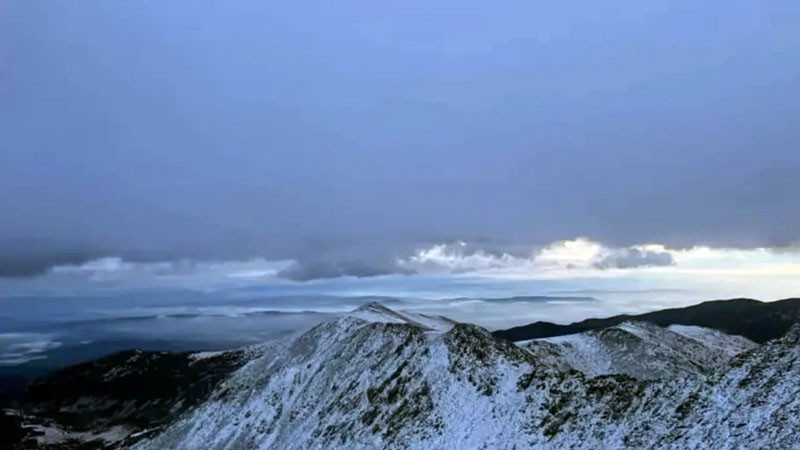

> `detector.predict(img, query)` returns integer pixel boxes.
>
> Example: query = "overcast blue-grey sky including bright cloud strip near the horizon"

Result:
[0,0,800,290]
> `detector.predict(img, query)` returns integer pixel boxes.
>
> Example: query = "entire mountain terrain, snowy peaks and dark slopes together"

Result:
[0,300,800,450]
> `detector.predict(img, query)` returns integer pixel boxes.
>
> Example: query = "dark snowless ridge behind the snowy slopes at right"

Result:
[493,298,800,343]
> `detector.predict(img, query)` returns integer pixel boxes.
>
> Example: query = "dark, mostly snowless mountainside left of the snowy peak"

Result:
[0,349,258,449]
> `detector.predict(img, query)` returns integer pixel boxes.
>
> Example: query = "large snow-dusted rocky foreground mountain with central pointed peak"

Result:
[135,308,800,450]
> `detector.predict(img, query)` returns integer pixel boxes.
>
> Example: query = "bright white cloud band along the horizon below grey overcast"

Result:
[3,238,800,287]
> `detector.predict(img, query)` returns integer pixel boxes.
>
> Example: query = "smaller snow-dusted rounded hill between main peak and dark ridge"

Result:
[521,322,756,379]
